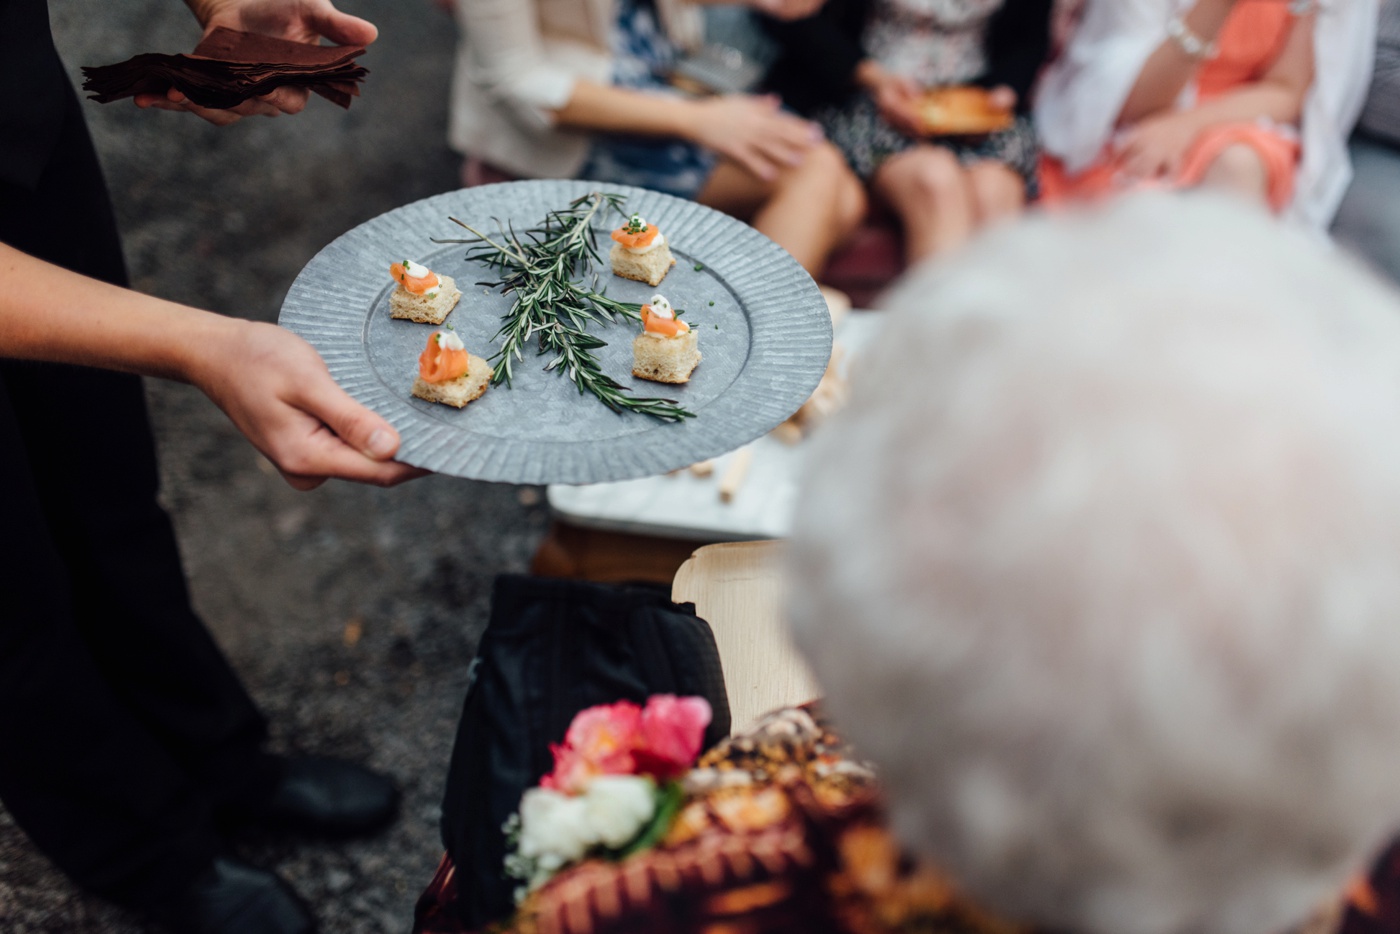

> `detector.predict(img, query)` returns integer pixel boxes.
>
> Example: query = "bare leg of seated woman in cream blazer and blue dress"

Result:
[696,143,865,276]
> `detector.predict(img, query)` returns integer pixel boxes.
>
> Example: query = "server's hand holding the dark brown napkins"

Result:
[136,0,379,126]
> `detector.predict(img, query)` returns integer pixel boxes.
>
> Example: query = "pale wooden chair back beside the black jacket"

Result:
[671,542,822,732]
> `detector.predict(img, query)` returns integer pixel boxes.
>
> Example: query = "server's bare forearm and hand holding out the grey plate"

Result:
[0,244,423,490]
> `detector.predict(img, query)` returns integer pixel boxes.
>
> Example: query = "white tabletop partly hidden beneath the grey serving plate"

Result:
[547,311,882,542]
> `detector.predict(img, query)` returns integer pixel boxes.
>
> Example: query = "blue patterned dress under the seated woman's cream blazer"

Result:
[578,0,715,199]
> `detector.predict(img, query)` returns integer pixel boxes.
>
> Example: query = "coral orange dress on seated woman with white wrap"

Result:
[1040,0,1301,211]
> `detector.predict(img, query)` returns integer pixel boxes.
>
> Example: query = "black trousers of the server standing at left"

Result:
[0,78,274,906]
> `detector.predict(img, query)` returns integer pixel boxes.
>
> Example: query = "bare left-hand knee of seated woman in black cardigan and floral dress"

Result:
[874,146,977,265]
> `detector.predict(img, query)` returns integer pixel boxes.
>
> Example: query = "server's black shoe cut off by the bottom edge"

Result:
[151,857,316,934]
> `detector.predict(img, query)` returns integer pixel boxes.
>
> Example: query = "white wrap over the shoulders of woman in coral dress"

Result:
[1036,0,1378,230]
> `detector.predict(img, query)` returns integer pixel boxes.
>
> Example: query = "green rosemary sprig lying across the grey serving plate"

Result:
[434,192,694,421]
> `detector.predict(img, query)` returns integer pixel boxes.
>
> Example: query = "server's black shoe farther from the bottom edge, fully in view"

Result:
[255,758,399,836]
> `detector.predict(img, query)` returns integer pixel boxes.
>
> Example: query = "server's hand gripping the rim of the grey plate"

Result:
[188,318,427,490]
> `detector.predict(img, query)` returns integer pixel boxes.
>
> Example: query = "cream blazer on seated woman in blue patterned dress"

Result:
[448,0,704,178]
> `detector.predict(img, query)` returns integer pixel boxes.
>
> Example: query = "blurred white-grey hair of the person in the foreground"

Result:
[790,195,1400,934]
